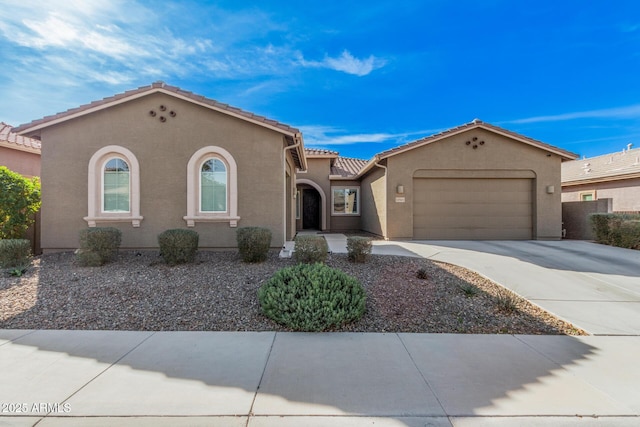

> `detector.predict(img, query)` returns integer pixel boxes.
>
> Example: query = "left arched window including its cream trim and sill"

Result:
[84,145,142,227]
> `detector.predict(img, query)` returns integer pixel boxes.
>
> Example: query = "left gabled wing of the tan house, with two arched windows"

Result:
[14,82,306,251]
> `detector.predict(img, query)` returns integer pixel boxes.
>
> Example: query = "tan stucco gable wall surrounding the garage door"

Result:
[367,128,562,239]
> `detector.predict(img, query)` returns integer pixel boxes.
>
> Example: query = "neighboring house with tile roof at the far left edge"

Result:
[0,122,40,178]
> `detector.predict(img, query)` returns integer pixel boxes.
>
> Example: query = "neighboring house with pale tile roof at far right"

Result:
[562,144,640,212]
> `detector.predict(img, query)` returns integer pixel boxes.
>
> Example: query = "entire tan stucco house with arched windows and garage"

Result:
[14,82,577,251]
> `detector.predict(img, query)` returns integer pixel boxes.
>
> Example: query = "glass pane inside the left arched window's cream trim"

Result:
[102,158,131,212]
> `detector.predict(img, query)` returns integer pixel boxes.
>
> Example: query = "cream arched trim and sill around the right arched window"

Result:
[183,146,240,227]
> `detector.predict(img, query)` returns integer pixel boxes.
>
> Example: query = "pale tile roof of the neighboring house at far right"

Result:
[562,147,640,184]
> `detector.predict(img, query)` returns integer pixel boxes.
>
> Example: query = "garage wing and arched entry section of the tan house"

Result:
[297,120,577,239]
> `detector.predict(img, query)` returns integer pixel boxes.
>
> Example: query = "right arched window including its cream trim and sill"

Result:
[184,146,240,227]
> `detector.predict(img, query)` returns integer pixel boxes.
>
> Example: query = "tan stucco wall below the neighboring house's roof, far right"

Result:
[562,178,640,212]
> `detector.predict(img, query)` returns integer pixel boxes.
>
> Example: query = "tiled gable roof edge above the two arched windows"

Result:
[14,81,306,169]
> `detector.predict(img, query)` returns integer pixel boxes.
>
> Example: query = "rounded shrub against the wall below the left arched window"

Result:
[76,227,122,267]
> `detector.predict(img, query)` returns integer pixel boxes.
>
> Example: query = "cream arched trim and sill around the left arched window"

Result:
[84,145,143,227]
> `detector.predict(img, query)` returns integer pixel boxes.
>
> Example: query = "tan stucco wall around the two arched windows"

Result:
[37,93,285,250]
